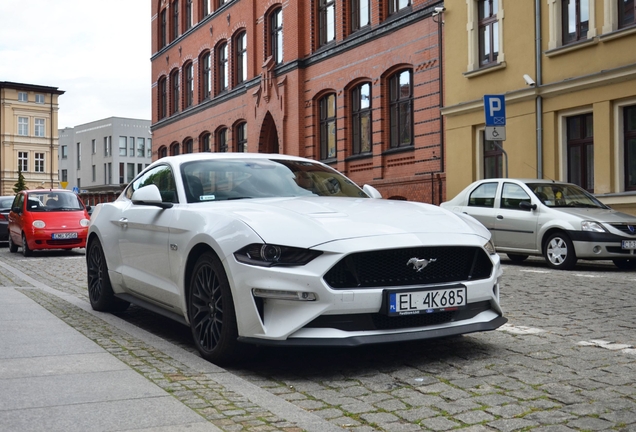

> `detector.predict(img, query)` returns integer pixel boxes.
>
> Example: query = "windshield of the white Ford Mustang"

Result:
[181,158,368,203]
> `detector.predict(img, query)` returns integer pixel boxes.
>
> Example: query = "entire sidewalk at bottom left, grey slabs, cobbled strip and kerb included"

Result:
[0,262,342,432]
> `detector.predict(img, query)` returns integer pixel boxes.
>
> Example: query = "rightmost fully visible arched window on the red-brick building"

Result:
[389,70,413,148]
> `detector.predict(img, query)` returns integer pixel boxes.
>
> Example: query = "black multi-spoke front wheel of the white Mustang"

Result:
[188,252,239,364]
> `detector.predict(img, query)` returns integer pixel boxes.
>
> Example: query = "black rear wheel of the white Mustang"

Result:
[86,239,130,312]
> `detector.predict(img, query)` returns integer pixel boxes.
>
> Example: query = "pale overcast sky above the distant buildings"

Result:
[0,0,151,129]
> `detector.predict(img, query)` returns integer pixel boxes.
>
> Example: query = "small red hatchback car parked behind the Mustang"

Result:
[9,189,90,256]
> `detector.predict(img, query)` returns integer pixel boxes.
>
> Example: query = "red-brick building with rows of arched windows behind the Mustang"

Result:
[151,0,445,203]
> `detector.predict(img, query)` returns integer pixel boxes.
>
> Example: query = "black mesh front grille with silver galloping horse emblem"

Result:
[324,246,492,289]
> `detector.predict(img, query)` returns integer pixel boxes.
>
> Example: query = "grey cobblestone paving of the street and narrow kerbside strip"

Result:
[0,249,636,432]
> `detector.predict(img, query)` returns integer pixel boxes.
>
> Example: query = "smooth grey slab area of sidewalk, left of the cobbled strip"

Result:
[0,287,220,432]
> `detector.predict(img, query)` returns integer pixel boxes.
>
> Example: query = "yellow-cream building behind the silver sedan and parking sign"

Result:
[443,0,636,214]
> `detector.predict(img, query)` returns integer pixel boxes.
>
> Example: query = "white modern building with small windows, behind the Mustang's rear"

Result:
[58,117,152,205]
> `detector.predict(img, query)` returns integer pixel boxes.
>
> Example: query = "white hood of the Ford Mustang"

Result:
[214,197,490,247]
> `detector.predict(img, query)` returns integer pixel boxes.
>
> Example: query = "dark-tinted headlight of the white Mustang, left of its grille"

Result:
[234,243,322,267]
